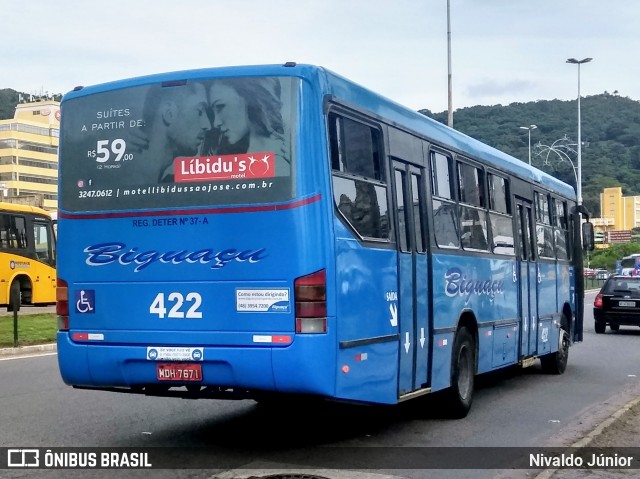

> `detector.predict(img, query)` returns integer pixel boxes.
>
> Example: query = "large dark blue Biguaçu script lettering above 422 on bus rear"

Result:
[84,242,267,273]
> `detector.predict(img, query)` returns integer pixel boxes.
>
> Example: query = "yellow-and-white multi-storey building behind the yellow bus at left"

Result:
[0,99,60,211]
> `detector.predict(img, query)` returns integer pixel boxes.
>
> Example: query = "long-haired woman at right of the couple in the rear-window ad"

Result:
[209,78,290,176]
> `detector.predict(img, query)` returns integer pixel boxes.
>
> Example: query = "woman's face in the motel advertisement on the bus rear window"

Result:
[209,83,250,145]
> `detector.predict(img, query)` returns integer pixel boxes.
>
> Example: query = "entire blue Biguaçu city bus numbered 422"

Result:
[57,63,592,417]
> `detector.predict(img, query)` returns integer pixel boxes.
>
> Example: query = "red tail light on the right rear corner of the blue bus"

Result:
[293,270,327,333]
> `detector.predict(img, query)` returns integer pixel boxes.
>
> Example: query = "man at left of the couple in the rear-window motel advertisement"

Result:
[136,83,211,183]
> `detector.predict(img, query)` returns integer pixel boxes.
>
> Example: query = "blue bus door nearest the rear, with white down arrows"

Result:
[393,162,430,396]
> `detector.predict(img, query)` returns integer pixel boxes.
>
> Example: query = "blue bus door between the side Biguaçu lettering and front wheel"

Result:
[516,198,538,358]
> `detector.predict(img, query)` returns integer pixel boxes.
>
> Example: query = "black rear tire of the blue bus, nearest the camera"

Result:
[446,326,476,419]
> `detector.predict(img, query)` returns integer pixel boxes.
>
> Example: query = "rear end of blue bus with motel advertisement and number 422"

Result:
[58,67,356,404]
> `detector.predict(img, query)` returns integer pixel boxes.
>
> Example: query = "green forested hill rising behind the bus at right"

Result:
[420,92,640,216]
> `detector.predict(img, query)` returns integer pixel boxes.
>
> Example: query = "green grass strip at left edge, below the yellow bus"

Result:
[0,313,58,348]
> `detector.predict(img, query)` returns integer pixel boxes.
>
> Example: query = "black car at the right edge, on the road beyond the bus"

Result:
[593,276,640,334]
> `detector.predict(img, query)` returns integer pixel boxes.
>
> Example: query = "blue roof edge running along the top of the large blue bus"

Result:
[63,63,576,199]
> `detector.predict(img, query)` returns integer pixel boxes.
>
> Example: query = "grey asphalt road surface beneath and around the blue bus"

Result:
[0,294,640,479]
